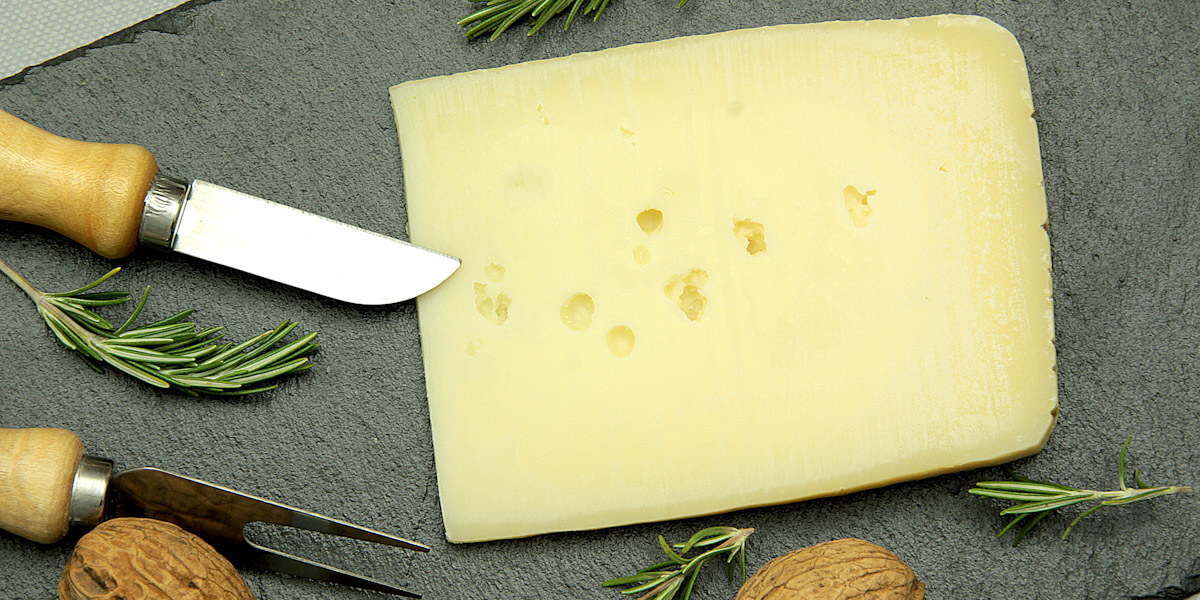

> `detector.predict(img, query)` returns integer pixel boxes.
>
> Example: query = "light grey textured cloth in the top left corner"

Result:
[0,0,184,79]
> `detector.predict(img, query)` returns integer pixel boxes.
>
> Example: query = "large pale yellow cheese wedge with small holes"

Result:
[391,16,1057,542]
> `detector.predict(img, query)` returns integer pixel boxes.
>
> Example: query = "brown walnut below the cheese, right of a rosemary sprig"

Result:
[737,539,925,600]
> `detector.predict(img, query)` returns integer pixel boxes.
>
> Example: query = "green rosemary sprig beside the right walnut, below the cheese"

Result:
[601,527,754,600]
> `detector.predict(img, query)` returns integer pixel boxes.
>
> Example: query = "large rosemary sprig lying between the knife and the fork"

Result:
[0,259,318,396]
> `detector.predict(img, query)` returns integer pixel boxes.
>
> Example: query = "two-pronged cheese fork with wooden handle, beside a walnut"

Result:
[0,428,430,598]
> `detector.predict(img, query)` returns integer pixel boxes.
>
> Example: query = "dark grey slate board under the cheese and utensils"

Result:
[0,0,1200,600]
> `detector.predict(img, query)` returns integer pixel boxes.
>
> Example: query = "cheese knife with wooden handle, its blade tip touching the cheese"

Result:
[0,110,460,305]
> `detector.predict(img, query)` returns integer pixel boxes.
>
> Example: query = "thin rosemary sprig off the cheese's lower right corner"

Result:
[968,437,1192,546]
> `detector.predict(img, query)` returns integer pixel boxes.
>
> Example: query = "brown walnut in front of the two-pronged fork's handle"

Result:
[59,518,254,600]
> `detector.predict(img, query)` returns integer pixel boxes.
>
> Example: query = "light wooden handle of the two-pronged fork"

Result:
[0,428,83,544]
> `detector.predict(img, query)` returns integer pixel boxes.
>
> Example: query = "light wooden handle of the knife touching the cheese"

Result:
[0,110,158,258]
